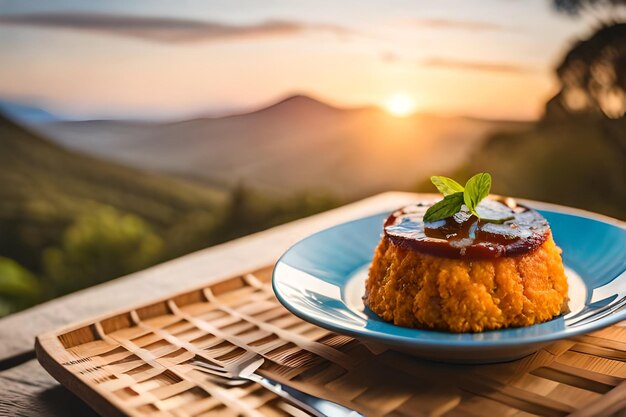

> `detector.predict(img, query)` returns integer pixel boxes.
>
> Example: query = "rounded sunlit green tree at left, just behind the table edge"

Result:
[43,206,163,296]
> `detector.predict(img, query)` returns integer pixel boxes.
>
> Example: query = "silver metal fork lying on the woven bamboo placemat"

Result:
[192,355,363,417]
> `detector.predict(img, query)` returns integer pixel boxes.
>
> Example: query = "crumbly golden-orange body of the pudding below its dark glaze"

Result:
[364,231,567,332]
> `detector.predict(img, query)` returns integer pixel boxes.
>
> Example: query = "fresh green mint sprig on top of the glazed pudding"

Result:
[424,172,491,222]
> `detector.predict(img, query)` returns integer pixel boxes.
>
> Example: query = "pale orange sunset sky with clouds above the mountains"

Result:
[0,0,590,119]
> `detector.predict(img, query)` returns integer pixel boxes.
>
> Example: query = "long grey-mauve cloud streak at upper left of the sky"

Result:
[0,13,351,43]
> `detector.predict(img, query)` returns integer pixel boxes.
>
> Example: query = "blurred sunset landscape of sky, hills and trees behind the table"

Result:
[0,0,626,317]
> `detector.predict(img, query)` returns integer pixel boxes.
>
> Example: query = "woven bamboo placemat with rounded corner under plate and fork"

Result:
[36,267,626,417]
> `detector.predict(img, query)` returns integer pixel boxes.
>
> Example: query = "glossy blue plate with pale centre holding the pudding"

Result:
[272,201,626,363]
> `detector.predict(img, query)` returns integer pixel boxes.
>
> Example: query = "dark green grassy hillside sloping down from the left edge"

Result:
[0,115,226,270]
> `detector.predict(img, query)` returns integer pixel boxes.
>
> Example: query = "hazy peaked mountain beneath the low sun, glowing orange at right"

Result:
[42,95,527,198]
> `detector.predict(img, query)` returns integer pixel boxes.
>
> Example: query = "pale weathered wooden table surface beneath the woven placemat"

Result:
[0,192,415,417]
